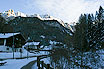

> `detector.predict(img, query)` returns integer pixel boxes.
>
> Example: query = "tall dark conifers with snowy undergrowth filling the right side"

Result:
[49,6,104,69]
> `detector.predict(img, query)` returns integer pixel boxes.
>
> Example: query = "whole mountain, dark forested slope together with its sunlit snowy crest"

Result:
[0,9,73,45]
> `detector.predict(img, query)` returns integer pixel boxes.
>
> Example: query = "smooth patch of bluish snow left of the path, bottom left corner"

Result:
[0,57,36,69]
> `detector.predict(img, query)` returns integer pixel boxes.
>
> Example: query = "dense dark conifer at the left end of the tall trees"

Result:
[74,14,88,51]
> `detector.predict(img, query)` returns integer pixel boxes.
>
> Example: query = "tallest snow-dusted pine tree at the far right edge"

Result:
[96,6,104,47]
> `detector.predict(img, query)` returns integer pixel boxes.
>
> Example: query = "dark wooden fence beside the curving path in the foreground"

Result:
[37,56,53,69]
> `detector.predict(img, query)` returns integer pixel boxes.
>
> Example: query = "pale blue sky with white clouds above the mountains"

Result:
[0,0,104,23]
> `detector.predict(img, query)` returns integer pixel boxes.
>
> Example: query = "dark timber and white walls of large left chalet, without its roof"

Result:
[0,34,25,52]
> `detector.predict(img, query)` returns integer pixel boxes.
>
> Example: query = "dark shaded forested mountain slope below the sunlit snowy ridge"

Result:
[5,17,71,44]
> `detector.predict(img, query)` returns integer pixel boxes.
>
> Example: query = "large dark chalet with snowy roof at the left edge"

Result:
[0,33,25,52]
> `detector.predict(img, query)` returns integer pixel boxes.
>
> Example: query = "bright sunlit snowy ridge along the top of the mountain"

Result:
[0,9,74,32]
